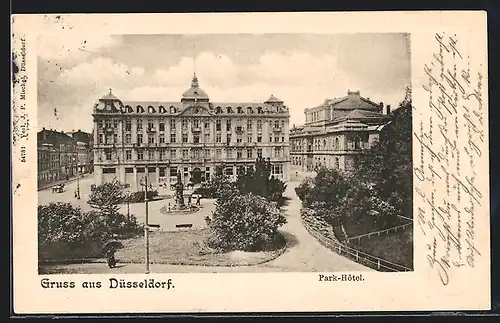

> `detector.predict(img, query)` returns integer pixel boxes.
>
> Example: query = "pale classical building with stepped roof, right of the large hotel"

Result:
[290,91,390,171]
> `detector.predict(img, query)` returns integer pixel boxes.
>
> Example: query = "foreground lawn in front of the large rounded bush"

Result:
[116,229,285,266]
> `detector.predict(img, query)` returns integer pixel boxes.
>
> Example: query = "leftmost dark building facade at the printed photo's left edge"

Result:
[38,143,60,186]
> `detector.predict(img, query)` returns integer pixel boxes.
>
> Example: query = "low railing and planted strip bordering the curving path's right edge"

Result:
[301,216,413,272]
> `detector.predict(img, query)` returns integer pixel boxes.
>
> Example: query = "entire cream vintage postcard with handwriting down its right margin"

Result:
[12,11,490,314]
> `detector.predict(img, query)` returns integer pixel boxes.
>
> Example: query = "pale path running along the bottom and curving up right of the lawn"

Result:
[41,173,373,273]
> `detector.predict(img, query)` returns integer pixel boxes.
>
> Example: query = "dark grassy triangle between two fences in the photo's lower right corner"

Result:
[356,228,413,269]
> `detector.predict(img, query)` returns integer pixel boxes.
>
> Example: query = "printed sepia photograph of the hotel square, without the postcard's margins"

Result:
[37,33,414,274]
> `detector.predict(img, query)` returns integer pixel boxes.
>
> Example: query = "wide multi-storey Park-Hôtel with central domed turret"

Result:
[93,75,290,189]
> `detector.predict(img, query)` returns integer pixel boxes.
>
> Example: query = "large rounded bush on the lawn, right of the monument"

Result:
[207,193,286,251]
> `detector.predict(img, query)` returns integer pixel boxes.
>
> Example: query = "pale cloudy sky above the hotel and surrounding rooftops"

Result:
[37,33,411,132]
